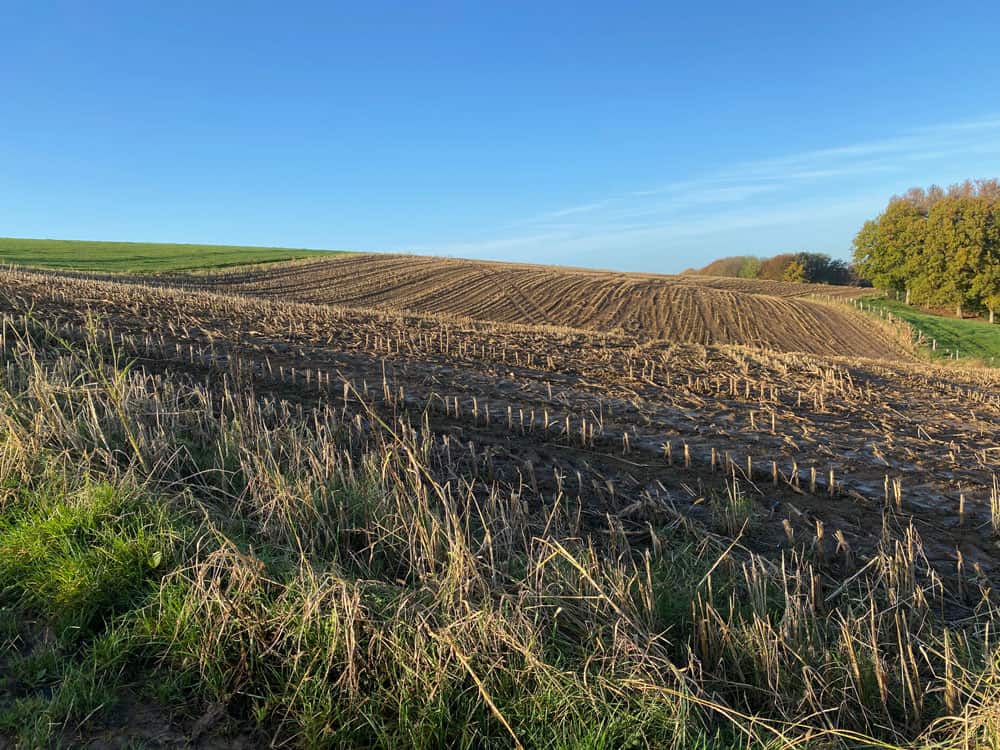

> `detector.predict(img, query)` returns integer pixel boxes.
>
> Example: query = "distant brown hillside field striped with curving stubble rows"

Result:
[92,255,906,358]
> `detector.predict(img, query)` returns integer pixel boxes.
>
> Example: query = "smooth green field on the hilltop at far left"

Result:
[0,237,334,273]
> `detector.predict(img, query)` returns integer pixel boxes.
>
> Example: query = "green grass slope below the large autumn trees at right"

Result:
[852,297,1000,367]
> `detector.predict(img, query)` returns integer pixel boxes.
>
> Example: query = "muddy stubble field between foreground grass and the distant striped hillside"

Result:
[0,274,1000,585]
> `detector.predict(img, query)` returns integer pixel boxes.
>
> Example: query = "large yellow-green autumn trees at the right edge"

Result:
[853,179,1000,323]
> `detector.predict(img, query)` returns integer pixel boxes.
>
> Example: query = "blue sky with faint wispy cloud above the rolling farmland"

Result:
[0,0,1000,272]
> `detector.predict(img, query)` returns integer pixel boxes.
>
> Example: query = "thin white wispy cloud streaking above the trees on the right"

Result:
[402,116,1000,272]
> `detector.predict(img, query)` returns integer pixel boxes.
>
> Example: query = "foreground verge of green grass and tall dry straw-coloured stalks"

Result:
[0,320,1000,750]
